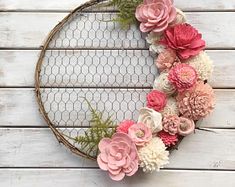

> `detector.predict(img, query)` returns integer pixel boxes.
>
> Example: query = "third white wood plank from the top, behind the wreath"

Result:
[0,50,235,88]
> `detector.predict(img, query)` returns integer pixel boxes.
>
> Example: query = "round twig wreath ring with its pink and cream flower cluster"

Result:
[35,0,214,180]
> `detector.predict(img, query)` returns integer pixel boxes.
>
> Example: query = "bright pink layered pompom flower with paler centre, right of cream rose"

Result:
[168,64,197,92]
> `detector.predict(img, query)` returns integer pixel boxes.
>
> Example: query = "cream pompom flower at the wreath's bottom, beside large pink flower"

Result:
[138,137,169,172]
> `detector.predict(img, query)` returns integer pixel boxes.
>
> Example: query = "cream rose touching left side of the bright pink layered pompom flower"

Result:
[153,72,176,96]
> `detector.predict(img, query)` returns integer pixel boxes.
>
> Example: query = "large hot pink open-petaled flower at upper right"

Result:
[160,23,205,60]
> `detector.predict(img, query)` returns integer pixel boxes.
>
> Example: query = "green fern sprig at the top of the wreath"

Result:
[110,0,143,28]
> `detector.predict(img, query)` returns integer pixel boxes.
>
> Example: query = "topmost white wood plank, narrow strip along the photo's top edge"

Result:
[0,0,235,11]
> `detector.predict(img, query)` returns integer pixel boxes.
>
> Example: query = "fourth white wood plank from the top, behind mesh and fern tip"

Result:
[0,88,235,128]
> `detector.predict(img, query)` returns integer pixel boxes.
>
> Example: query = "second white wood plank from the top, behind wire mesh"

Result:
[0,12,235,48]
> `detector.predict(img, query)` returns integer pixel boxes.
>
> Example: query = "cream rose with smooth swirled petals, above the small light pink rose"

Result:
[138,107,162,132]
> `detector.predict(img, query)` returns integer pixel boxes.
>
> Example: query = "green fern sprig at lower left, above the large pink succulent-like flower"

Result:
[74,99,116,157]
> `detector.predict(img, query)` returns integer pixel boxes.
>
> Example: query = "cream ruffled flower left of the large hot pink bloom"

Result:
[146,32,165,54]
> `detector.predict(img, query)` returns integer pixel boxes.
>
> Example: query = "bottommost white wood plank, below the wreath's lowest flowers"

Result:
[0,169,235,187]
